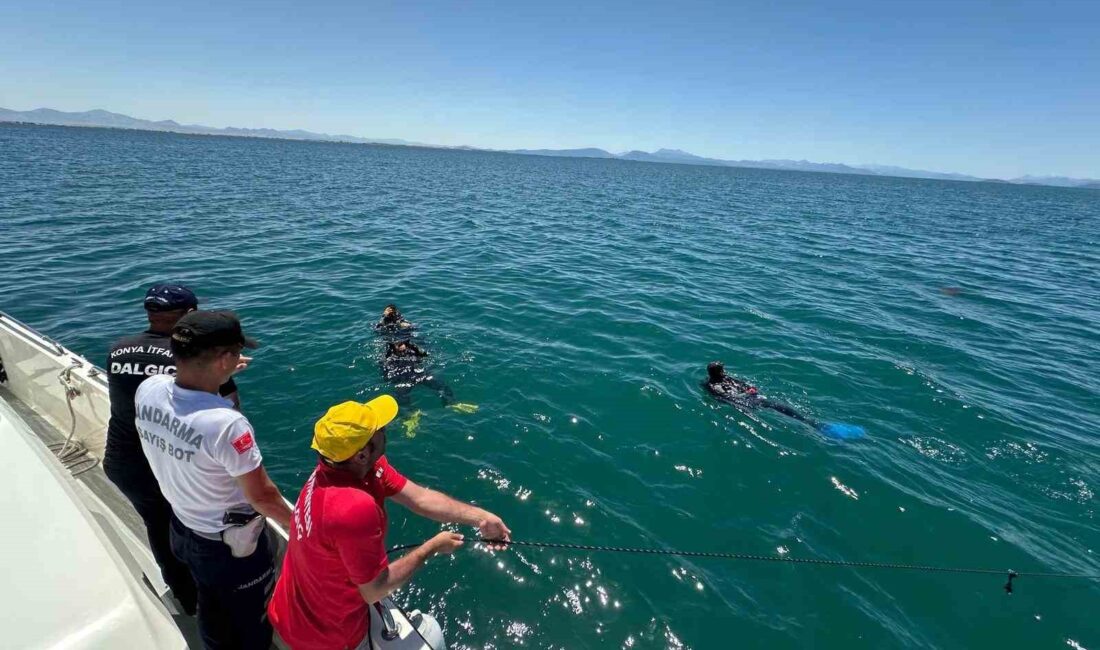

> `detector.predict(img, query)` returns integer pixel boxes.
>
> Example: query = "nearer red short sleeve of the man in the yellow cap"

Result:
[325,488,389,585]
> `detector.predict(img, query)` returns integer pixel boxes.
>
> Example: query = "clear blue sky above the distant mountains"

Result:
[0,0,1100,178]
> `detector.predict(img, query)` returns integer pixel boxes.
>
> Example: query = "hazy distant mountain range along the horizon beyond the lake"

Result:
[0,108,1100,189]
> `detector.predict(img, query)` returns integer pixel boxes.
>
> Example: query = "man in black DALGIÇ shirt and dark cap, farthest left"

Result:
[103,284,249,615]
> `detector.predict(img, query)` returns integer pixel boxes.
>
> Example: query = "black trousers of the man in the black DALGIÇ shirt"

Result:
[103,454,198,616]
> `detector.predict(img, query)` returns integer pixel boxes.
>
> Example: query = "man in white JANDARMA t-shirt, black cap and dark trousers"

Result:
[134,311,290,649]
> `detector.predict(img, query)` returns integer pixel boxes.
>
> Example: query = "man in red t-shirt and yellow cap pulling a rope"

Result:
[267,395,512,650]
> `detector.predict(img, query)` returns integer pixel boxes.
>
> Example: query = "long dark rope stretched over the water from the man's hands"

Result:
[386,538,1100,594]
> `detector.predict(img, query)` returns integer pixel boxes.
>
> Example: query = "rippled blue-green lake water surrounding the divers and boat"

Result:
[0,126,1100,649]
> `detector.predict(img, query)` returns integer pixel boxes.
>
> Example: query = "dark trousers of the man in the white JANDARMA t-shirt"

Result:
[171,517,275,650]
